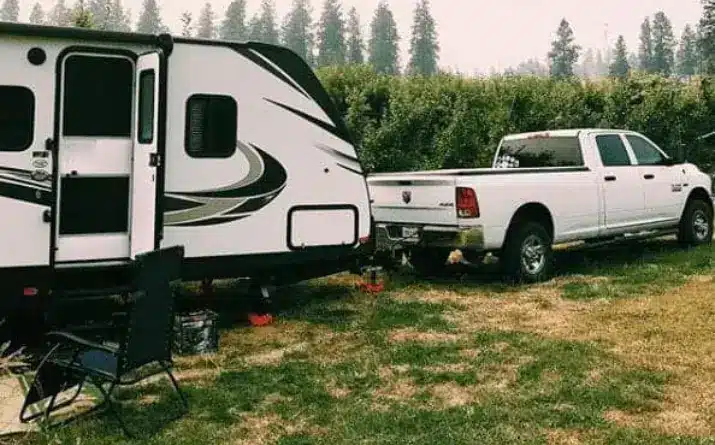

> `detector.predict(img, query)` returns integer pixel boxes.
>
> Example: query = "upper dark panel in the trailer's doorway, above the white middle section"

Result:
[62,55,134,137]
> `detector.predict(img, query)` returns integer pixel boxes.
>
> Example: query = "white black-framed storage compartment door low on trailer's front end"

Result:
[288,204,359,250]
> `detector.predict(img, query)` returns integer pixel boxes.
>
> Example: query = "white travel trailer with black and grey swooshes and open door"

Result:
[0,23,371,326]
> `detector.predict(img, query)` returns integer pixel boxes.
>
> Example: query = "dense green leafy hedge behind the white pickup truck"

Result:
[318,66,715,172]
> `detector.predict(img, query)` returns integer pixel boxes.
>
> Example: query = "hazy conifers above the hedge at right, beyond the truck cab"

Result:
[548,0,715,78]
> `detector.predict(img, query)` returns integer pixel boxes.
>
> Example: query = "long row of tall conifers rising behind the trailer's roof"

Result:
[0,0,440,76]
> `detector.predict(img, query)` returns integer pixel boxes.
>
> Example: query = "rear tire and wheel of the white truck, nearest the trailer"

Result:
[500,222,554,283]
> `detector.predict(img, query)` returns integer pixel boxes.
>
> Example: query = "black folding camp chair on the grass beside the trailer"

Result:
[20,246,188,436]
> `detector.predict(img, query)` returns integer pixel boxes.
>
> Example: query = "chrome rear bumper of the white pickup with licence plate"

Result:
[375,223,484,251]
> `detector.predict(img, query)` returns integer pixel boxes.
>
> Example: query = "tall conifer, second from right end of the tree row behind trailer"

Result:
[368,0,400,74]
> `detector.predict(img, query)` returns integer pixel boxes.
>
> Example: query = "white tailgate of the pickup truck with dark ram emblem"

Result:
[367,174,457,225]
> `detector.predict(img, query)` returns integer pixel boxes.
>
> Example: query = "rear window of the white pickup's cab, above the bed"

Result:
[494,136,584,168]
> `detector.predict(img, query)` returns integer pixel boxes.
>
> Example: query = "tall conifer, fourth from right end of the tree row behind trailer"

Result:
[317,0,347,66]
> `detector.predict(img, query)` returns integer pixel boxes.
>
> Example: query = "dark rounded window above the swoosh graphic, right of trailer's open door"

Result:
[184,94,238,158]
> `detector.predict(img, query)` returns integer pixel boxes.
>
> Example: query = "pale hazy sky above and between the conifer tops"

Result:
[21,0,702,74]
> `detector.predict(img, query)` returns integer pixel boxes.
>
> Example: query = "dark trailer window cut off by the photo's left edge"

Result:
[0,86,35,151]
